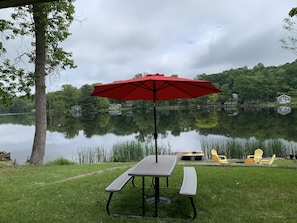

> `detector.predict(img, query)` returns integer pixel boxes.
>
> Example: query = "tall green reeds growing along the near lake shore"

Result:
[76,138,297,164]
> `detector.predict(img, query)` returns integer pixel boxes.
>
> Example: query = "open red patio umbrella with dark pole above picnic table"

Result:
[92,74,220,162]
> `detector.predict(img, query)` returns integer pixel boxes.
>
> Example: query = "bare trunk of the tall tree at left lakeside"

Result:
[30,4,47,164]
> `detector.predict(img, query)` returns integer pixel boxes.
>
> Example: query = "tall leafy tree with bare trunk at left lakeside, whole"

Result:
[0,0,75,164]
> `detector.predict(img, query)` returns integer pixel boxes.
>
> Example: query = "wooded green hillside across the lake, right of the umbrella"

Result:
[196,61,297,103]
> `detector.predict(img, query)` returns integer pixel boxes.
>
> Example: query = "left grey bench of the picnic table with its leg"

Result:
[105,167,135,215]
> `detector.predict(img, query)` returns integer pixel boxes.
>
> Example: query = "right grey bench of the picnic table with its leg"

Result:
[179,167,197,220]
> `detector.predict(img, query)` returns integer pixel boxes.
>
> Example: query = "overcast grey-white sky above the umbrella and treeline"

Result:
[1,0,297,91]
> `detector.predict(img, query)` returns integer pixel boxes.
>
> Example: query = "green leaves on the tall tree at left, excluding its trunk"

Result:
[0,0,75,104]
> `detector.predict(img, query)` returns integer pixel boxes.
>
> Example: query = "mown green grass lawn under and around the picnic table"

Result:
[0,160,297,223]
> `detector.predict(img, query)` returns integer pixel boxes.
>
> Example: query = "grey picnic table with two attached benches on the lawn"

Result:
[105,155,197,220]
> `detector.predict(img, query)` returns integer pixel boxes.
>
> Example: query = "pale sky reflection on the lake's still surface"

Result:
[0,124,201,164]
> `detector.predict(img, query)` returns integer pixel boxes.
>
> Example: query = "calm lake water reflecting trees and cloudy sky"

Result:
[0,108,297,164]
